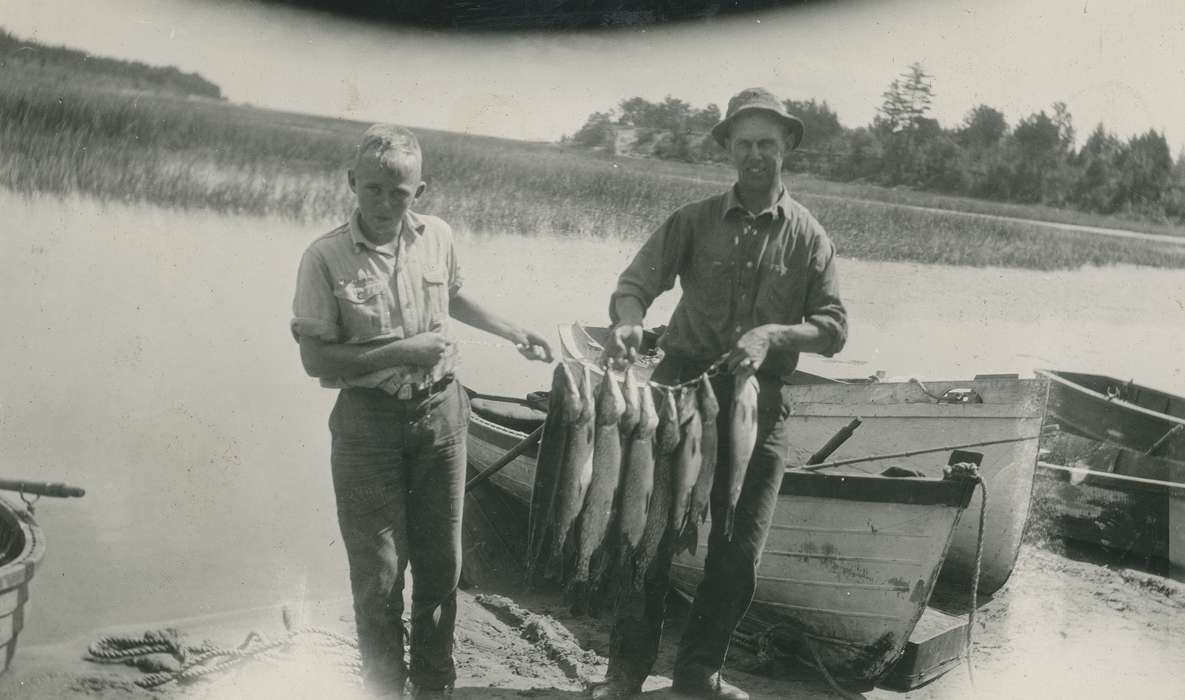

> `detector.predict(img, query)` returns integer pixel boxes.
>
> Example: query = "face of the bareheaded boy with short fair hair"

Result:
[350,152,424,240]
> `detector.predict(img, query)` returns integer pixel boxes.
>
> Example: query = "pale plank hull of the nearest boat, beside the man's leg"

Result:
[671,471,973,688]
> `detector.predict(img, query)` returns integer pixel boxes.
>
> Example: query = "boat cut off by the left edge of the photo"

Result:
[0,497,45,673]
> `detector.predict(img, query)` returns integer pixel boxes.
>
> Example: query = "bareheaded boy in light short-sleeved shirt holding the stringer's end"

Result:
[292,124,551,698]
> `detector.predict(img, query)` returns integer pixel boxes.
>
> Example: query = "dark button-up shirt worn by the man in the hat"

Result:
[609,190,847,380]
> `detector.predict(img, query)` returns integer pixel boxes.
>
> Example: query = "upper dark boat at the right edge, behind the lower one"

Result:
[1039,370,1185,462]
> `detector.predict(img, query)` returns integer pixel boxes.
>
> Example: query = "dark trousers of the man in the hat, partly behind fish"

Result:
[608,358,789,686]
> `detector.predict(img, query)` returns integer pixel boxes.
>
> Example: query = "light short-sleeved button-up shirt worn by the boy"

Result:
[292,211,461,394]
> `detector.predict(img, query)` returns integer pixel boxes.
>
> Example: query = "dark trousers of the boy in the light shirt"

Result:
[329,381,469,692]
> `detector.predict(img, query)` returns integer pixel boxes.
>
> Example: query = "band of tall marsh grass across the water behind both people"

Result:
[0,77,1185,269]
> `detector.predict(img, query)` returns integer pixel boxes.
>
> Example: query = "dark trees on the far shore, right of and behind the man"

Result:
[565,63,1185,223]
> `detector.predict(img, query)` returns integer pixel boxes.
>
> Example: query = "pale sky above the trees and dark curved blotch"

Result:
[0,0,1185,155]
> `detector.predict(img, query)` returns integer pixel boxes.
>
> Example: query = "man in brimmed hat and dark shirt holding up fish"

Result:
[594,88,847,699]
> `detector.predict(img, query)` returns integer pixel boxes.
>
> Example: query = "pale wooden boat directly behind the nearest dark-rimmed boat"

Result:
[554,323,1048,595]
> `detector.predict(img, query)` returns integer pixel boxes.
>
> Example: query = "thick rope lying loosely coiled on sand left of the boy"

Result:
[88,615,358,689]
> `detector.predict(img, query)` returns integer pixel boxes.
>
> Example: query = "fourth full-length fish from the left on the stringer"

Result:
[617,371,659,554]
